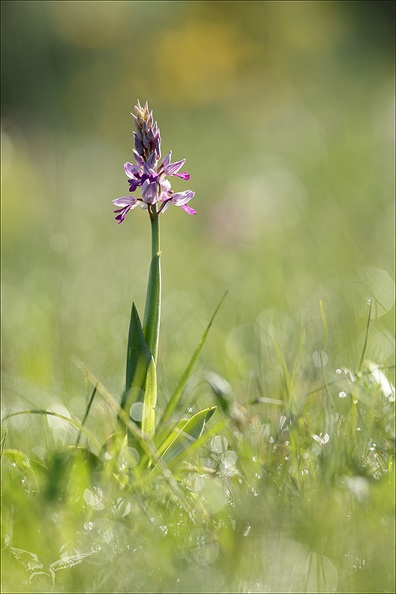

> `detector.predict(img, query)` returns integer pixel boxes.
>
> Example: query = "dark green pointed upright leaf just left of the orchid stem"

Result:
[121,303,151,410]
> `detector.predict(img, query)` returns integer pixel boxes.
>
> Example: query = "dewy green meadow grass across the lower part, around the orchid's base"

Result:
[2,294,394,592]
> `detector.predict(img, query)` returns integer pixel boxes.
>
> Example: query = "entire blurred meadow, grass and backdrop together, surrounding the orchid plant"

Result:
[2,2,395,592]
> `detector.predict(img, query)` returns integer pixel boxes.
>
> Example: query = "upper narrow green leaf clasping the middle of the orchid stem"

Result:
[143,253,161,363]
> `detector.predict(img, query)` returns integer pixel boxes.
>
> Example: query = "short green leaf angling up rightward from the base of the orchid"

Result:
[158,406,217,464]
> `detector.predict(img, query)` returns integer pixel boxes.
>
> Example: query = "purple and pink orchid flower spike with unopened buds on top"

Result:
[113,101,196,223]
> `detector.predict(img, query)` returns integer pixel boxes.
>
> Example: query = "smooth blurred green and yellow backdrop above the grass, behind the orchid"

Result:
[2,2,394,416]
